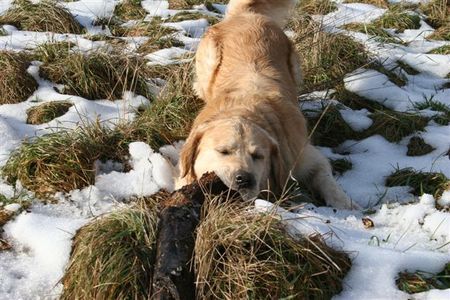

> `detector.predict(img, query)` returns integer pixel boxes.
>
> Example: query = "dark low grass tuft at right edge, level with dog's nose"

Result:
[386,168,450,199]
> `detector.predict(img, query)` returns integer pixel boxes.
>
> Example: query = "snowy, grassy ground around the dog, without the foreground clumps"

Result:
[0,0,450,299]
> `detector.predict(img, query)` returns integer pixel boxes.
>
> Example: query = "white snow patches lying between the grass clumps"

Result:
[0,0,450,299]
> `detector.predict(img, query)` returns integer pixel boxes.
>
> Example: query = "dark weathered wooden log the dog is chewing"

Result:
[152,173,236,300]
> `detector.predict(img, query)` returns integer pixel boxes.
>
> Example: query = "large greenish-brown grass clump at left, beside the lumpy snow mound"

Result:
[1,123,134,198]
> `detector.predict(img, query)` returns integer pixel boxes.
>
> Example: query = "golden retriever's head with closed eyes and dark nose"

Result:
[180,118,282,200]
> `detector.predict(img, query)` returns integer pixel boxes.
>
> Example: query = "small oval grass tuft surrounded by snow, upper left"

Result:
[27,101,72,125]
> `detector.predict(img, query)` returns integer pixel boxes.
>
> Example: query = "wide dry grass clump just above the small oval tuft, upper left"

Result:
[40,50,151,100]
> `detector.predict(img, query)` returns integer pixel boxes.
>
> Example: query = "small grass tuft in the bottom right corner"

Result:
[395,264,450,294]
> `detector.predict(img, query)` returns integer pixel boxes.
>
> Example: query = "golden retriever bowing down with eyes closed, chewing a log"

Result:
[176,0,355,209]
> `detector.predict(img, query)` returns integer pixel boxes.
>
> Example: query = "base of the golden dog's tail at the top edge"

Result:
[226,0,297,27]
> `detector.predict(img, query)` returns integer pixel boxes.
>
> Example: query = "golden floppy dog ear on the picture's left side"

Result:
[179,129,203,182]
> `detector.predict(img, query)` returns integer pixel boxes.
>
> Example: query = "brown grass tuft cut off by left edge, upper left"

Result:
[0,51,38,104]
